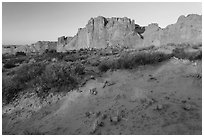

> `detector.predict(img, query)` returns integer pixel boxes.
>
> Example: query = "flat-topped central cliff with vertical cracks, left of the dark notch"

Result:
[58,16,144,51]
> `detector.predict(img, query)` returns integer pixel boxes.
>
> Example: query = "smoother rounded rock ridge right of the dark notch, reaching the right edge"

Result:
[143,14,202,46]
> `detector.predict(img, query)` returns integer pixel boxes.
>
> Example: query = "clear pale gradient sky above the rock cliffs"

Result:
[2,2,202,45]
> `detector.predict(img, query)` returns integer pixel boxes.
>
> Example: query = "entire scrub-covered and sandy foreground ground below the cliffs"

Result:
[2,44,202,134]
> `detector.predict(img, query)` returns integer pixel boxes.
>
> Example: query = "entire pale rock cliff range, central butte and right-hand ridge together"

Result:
[57,14,202,52]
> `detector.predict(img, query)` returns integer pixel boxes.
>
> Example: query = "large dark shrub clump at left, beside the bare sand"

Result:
[2,62,81,102]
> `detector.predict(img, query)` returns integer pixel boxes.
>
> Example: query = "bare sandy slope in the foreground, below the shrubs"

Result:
[3,59,202,134]
